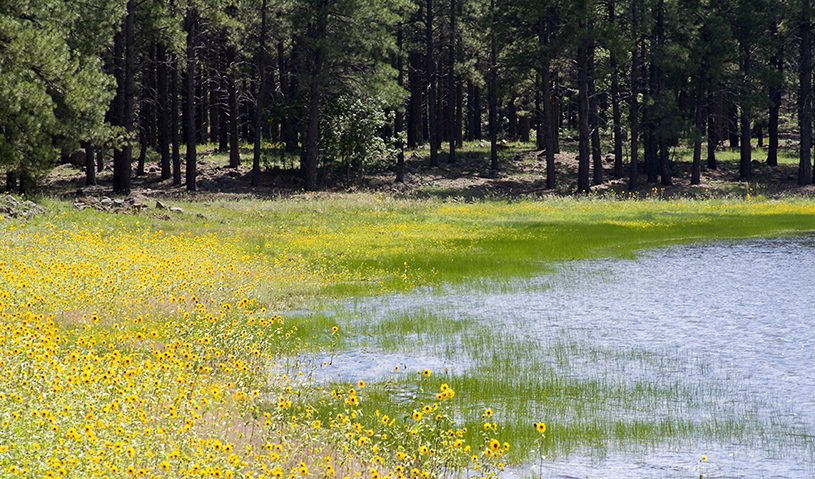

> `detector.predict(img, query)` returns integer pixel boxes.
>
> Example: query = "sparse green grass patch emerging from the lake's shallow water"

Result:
[306,298,813,462]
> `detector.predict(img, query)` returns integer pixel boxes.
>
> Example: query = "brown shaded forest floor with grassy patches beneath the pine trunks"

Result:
[41,143,815,201]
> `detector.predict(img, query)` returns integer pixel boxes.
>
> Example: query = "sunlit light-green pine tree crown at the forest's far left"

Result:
[0,0,124,190]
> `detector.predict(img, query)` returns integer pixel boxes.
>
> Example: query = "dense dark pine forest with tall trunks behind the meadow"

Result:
[0,0,813,194]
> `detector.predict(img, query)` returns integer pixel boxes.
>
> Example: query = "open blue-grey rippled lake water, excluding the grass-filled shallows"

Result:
[302,236,815,478]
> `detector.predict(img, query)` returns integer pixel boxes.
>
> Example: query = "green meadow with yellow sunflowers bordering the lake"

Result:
[0,194,815,479]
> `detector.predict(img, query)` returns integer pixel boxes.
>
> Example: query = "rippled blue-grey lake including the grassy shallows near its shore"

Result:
[300,236,815,478]
